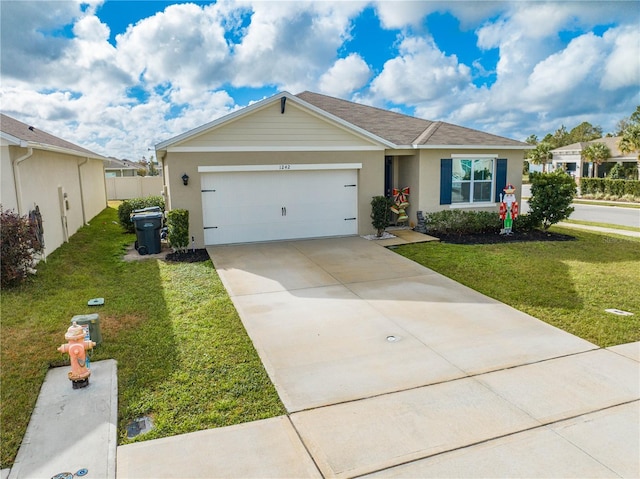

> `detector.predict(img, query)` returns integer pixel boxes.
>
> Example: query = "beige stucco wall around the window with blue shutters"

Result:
[412,148,524,215]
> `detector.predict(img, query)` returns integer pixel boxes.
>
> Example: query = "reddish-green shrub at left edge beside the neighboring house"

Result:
[0,205,43,288]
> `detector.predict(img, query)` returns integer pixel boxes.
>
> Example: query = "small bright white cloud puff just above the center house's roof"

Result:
[318,53,371,97]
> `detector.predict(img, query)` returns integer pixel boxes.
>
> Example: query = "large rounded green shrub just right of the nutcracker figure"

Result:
[529,171,576,229]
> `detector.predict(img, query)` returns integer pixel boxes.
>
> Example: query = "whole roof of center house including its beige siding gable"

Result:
[156,91,532,151]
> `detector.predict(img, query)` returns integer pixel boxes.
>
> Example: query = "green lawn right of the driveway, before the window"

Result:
[396,227,640,347]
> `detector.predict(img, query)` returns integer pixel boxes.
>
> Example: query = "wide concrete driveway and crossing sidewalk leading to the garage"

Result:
[118,237,640,477]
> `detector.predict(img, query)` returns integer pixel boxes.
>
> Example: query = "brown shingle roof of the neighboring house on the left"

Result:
[0,113,104,160]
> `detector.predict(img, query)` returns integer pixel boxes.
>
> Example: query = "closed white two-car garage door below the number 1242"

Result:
[201,165,358,245]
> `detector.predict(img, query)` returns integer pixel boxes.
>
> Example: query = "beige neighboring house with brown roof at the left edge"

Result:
[0,114,107,254]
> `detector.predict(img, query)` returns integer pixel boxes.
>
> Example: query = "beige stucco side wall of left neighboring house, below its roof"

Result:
[2,146,107,254]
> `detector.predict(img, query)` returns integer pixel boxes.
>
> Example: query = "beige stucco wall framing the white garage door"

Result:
[164,150,384,247]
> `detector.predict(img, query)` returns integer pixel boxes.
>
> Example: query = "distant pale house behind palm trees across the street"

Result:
[551,136,640,178]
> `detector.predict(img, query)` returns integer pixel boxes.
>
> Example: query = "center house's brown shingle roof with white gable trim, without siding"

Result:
[156,91,533,150]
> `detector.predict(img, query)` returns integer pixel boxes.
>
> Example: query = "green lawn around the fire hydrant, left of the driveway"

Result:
[0,208,285,467]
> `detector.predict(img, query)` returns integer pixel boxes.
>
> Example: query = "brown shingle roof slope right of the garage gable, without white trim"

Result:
[296,91,529,147]
